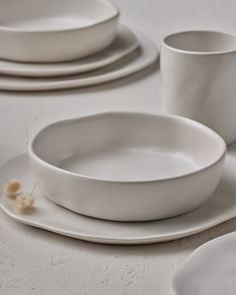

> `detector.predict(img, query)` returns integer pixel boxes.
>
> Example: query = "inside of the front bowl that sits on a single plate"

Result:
[32,113,225,181]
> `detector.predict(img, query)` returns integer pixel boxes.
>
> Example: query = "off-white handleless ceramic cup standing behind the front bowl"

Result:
[161,31,236,144]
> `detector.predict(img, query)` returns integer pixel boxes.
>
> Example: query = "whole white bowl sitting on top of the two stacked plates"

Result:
[0,0,119,62]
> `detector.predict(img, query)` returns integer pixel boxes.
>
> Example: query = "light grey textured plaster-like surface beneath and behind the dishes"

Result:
[0,0,236,295]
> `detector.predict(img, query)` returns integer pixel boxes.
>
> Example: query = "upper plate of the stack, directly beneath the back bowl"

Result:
[0,26,138,77]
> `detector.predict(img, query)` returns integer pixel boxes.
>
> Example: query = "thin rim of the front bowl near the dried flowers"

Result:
[28,111,227,184]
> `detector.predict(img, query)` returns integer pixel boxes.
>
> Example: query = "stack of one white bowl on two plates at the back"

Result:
[0,0,158,91]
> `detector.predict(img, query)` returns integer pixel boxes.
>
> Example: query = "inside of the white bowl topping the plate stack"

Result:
[0,0,118,31]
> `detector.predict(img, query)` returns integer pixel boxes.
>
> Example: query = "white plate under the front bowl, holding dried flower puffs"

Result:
[0,150,236,244]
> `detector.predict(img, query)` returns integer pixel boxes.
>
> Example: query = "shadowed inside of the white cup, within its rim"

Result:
[164,31,236,53]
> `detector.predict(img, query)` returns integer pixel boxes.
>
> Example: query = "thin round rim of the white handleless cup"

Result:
[161,30,236,55]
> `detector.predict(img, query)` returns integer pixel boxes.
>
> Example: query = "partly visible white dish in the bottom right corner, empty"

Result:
[173,232,236,295]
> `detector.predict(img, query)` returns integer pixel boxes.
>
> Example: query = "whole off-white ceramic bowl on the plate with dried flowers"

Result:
[29,112,226,221]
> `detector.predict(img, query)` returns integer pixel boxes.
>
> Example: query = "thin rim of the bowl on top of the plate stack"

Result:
[0,0,120,34]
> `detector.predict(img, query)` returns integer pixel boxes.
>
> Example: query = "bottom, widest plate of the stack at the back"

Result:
[0,33,159,91]
